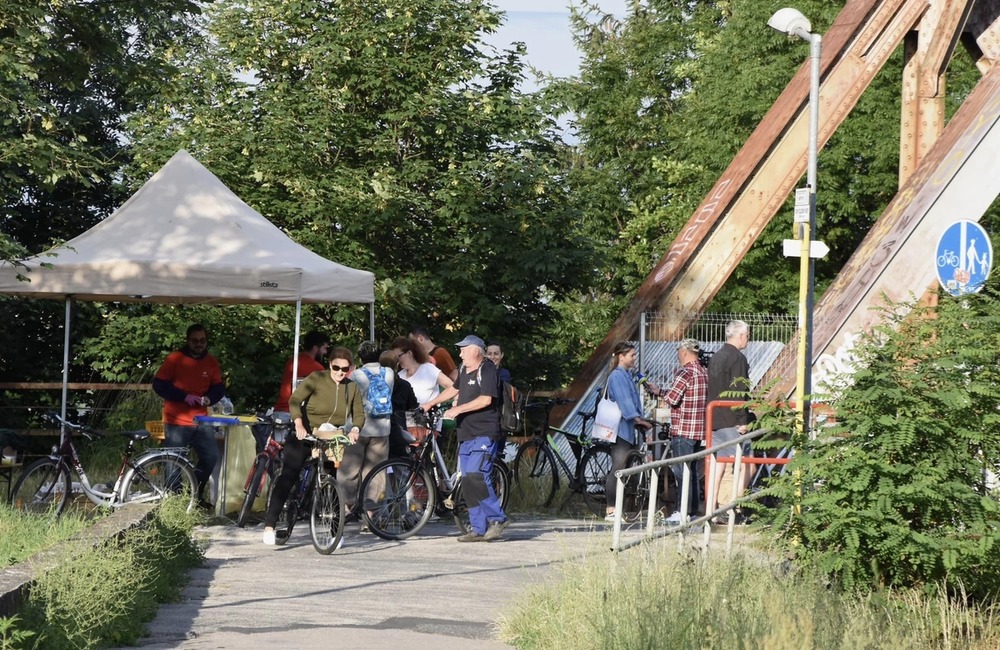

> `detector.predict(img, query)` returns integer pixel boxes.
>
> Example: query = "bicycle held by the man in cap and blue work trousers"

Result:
[360,408,510,540]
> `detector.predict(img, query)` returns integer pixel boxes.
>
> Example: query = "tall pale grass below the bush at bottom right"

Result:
[499,544,1000,650]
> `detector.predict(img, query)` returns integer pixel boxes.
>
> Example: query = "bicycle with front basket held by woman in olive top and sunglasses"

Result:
[267,426,351,555]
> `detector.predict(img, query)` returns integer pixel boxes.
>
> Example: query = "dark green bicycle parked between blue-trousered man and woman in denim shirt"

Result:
[513,397,611,517]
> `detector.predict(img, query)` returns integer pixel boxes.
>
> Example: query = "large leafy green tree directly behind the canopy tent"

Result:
[118,0,593,388]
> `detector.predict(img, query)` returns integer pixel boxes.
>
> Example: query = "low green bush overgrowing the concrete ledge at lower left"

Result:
[12,499,202,649]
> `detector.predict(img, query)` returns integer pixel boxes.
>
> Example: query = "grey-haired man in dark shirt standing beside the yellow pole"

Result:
[706,320,750,510]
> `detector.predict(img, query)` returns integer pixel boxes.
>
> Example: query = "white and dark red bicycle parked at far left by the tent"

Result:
[10,413,198,517]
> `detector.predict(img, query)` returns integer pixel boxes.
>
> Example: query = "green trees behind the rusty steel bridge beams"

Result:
[551,0,978,330]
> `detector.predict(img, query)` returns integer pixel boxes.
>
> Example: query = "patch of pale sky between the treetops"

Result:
[487,0,626,90]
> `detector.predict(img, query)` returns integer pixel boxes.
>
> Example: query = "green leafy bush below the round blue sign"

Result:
[761,288,1000,598]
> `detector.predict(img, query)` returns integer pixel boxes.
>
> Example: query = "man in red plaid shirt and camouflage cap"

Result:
[661,339,708,524]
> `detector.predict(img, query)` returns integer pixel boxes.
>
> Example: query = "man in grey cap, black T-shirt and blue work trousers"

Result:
[425,335,507,542]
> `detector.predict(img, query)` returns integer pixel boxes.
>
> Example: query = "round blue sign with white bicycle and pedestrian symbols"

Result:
[935,219,993,296]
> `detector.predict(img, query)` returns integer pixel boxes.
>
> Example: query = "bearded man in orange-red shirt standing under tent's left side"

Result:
[153,324,226,508]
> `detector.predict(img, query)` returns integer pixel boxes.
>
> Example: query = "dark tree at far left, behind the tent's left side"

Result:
[0,0,198,416]
